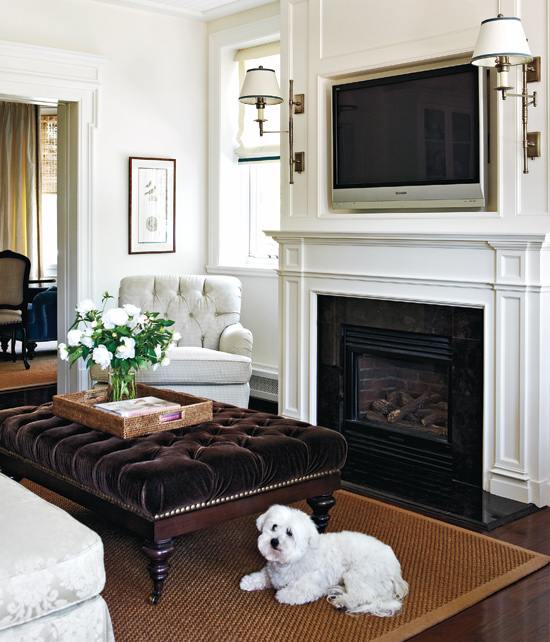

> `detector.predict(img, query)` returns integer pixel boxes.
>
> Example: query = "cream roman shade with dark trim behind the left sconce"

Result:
[234,42,284,160]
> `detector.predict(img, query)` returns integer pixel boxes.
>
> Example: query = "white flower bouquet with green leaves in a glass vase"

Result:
[58,292,181,401]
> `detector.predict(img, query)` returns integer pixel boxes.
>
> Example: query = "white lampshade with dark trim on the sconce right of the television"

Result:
[471,16,533,67]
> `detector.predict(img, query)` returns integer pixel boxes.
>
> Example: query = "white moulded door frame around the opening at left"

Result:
[0,40,107,394]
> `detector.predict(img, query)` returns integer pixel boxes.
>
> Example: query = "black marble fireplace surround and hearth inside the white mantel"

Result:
[317,295,536,530]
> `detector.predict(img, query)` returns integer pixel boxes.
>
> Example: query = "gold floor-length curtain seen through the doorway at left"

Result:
[0,102,41,278]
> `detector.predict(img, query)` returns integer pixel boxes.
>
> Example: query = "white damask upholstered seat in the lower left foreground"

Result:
[0,473,114,642]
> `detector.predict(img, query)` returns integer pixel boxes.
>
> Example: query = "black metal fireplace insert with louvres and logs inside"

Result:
[341,322,472,503]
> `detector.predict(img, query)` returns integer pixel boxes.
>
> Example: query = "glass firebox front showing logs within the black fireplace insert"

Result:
[346,328,451,441]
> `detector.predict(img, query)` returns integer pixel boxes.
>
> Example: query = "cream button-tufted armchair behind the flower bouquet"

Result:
[91,275,252,408]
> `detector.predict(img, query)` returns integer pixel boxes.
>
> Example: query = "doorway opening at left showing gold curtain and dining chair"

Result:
[0,96,57,380]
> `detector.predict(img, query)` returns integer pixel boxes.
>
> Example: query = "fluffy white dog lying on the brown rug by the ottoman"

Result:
[240,505,409,617]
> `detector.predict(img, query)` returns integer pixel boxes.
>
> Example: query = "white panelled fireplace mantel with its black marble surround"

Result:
[273,230,550,519]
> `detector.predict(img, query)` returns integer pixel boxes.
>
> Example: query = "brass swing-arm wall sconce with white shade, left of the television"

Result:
[239,66,305,185]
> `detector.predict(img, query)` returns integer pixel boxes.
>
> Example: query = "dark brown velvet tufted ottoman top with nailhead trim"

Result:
[0,402,347,519]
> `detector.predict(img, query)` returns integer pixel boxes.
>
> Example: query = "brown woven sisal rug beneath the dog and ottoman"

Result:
[24,481,550,642]
